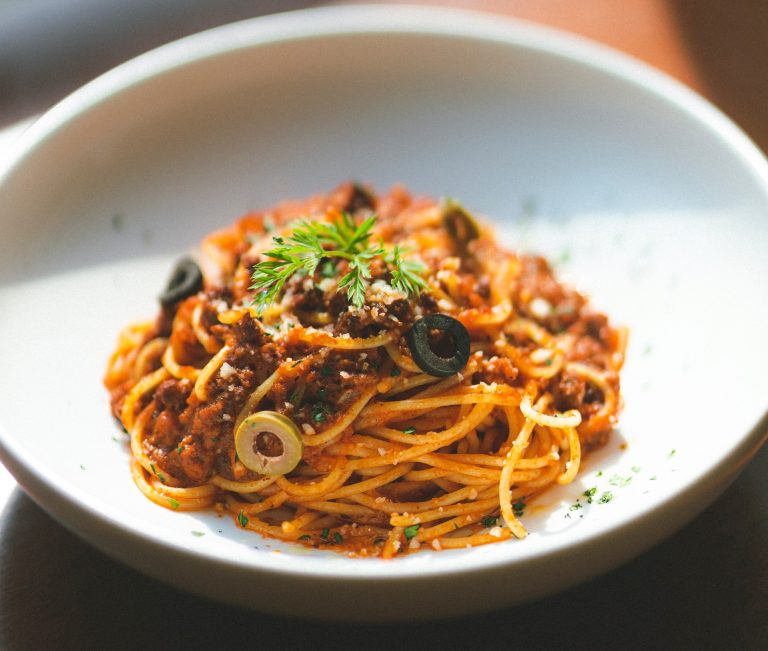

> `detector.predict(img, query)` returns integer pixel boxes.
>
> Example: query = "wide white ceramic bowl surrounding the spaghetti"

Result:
[0,7,768,620]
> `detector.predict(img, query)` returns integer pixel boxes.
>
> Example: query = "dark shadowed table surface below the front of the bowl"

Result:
[0,446,768,651]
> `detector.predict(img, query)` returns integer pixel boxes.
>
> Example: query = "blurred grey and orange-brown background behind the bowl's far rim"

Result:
[0,0,768,151]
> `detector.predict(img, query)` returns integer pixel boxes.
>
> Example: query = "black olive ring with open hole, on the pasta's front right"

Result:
[406,314,469,377]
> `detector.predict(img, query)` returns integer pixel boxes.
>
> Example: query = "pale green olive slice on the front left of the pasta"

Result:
[235,411,304,475]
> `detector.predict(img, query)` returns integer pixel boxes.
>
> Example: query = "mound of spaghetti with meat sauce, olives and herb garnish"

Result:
[105,183,626,558]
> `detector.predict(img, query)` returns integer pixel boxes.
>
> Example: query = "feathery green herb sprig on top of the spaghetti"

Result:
[251,213,427,312]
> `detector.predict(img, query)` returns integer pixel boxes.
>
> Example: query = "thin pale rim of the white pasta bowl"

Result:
[0,5,768,582]
